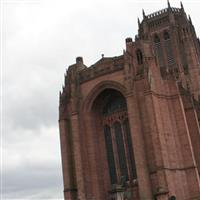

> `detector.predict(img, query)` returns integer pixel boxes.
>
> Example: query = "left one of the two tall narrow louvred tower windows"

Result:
[154,35,164,67]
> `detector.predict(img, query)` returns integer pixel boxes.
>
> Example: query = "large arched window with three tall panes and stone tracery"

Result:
[101,89,137,184]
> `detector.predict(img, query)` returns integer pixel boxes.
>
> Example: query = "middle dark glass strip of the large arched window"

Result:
[114,122,128,180]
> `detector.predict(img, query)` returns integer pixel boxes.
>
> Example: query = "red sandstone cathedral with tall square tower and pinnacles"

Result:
[59,2,200,200]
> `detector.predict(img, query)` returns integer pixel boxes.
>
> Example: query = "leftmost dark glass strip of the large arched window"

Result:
[104,126,117,184]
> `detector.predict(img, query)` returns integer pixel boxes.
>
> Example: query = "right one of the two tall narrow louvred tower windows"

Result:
[164,31,174,66]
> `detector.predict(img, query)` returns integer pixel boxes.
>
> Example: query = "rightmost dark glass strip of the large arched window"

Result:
[123,119,137,179]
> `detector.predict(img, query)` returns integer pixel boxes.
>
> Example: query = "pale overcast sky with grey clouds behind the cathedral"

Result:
[0,0,200,199]
